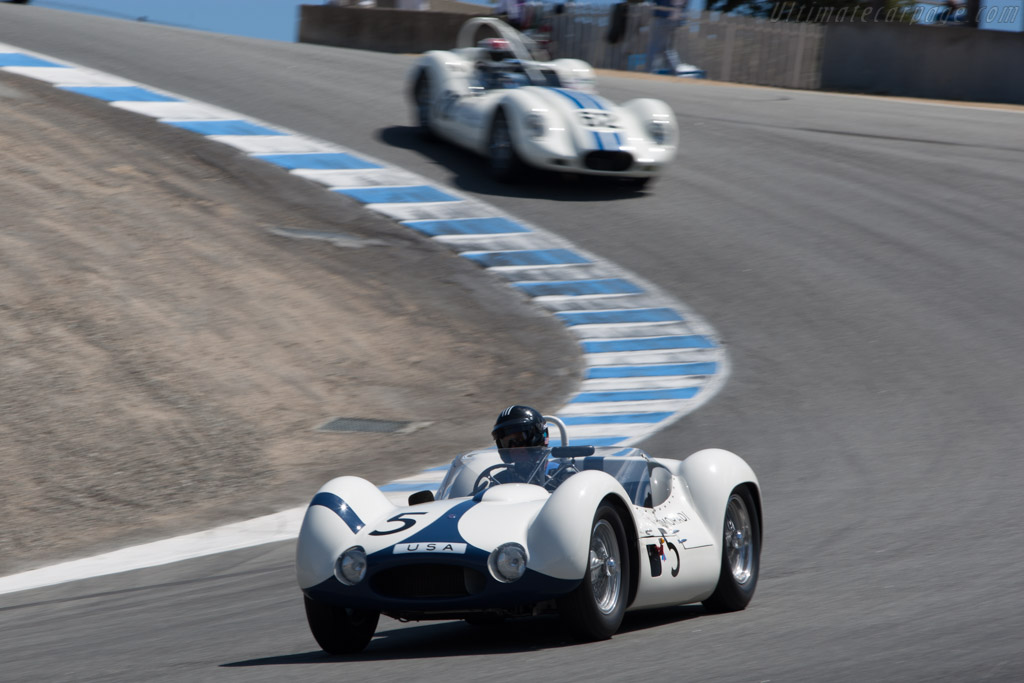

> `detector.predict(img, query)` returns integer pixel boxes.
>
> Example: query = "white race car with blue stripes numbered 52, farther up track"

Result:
[410,17,679,187]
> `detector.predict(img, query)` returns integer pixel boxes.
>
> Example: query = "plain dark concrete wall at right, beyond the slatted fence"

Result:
[821,23,1024,104]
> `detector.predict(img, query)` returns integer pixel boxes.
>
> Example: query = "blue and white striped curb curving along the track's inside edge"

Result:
[0,43,729,593]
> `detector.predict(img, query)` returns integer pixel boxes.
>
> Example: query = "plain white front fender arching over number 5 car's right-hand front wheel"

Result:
[527,470,631,581]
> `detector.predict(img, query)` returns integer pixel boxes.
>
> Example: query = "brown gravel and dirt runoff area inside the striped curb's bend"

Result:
[0,75,580,575]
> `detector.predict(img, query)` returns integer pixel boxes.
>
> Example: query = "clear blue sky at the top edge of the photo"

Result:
[24,0,1024,42]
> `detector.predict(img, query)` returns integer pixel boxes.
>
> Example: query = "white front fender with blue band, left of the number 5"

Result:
[295,476,396,589]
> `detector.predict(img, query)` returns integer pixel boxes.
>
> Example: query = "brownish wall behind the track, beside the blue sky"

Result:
[299,5,488,53]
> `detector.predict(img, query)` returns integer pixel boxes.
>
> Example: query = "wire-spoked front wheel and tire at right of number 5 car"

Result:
[558,503,631,640]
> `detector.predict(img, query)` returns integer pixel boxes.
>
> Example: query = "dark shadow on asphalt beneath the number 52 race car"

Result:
[378,126,656,202]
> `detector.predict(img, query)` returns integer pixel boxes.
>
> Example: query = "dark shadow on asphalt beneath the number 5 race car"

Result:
[220,605,708,668]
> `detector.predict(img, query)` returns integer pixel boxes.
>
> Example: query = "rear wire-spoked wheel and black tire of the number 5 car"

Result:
[703,486,761,612]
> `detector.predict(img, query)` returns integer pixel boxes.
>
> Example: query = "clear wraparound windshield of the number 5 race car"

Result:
[437,445,650,505]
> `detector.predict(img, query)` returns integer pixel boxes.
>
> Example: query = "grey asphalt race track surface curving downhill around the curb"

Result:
[0,6,1024,683]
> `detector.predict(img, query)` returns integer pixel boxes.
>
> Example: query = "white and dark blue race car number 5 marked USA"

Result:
[297,417,762,654]
